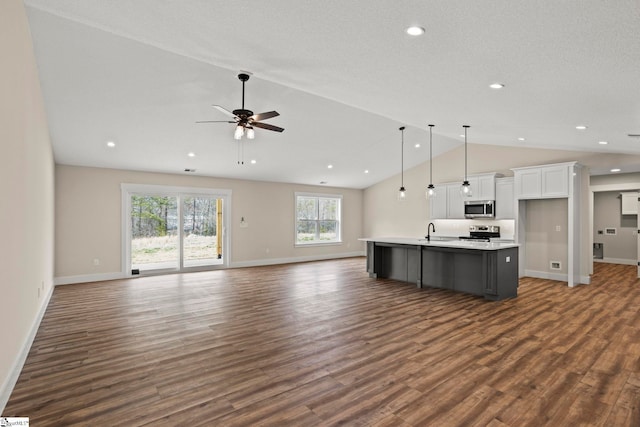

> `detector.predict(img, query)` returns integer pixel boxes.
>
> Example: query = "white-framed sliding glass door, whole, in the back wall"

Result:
[122,184,231,275]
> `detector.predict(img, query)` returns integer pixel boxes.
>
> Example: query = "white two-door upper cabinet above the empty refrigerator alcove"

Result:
[512,162,575,200]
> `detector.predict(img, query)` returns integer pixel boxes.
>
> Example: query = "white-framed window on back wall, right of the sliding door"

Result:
[296,193,342,245]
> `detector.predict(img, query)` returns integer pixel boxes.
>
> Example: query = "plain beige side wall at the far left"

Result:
[0,0,54,415]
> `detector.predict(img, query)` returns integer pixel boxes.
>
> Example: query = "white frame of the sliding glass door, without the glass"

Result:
[120,183,232,277]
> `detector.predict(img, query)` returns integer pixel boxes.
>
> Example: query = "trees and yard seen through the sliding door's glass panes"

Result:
[131,195,222,268]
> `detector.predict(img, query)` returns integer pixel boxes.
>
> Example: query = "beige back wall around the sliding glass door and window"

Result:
[55,165,364,283]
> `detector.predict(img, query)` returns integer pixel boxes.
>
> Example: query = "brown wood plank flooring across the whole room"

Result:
[3,258,640,427]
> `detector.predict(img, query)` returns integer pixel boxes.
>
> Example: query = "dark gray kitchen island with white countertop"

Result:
[361,237,518,301]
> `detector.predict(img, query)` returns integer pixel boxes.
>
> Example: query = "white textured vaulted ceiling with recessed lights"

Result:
[25,0,640,188]
